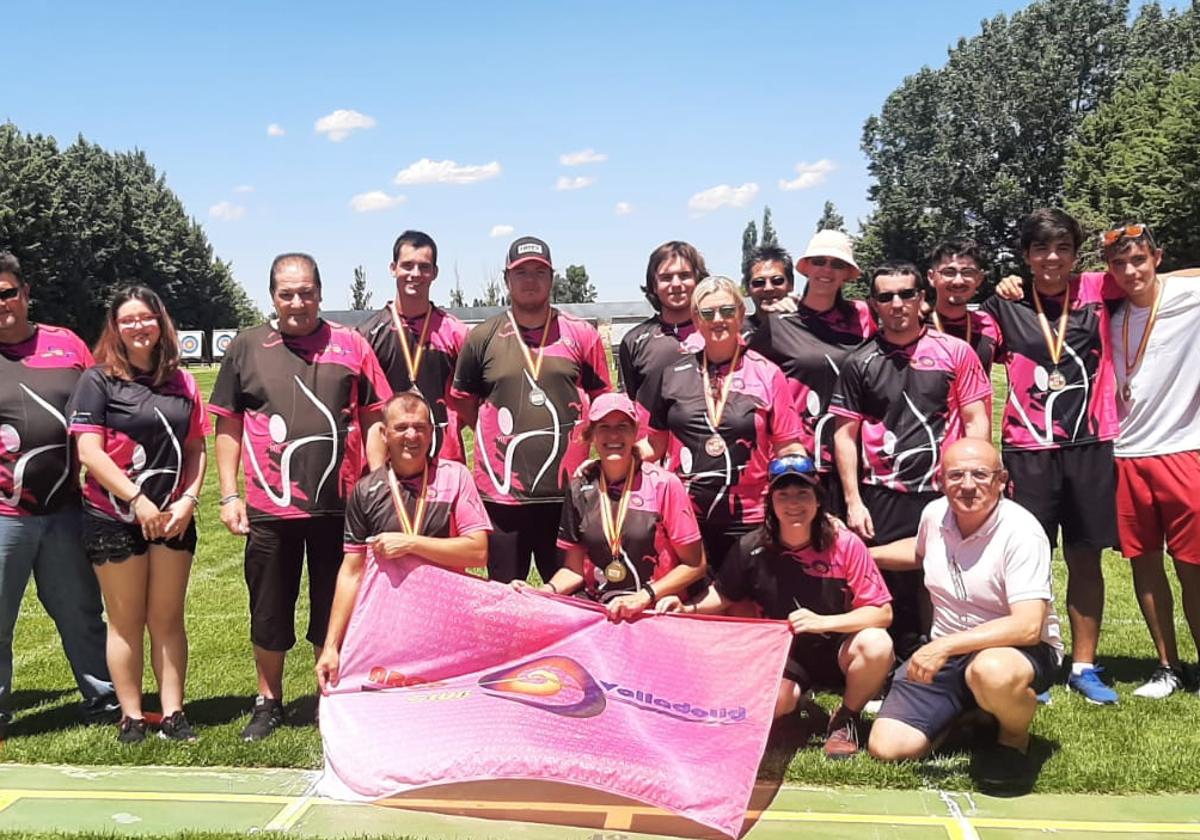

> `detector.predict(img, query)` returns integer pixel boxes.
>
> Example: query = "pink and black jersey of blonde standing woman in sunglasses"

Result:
[638,350,803,523]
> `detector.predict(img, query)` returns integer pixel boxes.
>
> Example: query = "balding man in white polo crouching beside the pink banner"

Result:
[869,438,1062,785]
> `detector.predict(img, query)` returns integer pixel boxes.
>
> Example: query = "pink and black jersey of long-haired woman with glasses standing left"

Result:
[71,367,209,522]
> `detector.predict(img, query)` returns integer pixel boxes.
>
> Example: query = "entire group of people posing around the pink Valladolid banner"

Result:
[0,210,1200,778]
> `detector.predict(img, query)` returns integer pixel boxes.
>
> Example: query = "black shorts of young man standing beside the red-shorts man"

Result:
[1004,442,1117,548]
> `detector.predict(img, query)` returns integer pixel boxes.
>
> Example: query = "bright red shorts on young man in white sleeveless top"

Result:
[1116,451,1200,564]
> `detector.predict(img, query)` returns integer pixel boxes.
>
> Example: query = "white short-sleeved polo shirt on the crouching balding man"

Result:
[917,497,1062,661]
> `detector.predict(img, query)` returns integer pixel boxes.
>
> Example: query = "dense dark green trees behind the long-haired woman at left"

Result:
[0,122,262,341]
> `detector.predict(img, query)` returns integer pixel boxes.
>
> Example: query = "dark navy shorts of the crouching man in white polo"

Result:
[878,642,1058,740]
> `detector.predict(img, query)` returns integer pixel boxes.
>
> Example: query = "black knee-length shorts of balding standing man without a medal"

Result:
[245,516,342,650]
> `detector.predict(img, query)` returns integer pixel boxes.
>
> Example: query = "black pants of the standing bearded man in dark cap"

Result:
[484,502,563,583]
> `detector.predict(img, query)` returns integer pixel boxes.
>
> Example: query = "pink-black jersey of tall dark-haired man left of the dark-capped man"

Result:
[356,304,470,462]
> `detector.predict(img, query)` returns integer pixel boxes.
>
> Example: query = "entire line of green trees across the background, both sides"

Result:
[0,0,1200,333]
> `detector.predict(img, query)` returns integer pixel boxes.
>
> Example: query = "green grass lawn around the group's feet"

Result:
[0,371,1200,793]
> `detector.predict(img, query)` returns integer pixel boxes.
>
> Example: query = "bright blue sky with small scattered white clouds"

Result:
[9,0,1065,310]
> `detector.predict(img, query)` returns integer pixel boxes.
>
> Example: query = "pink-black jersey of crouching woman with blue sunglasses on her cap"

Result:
[716,528,892,619]
